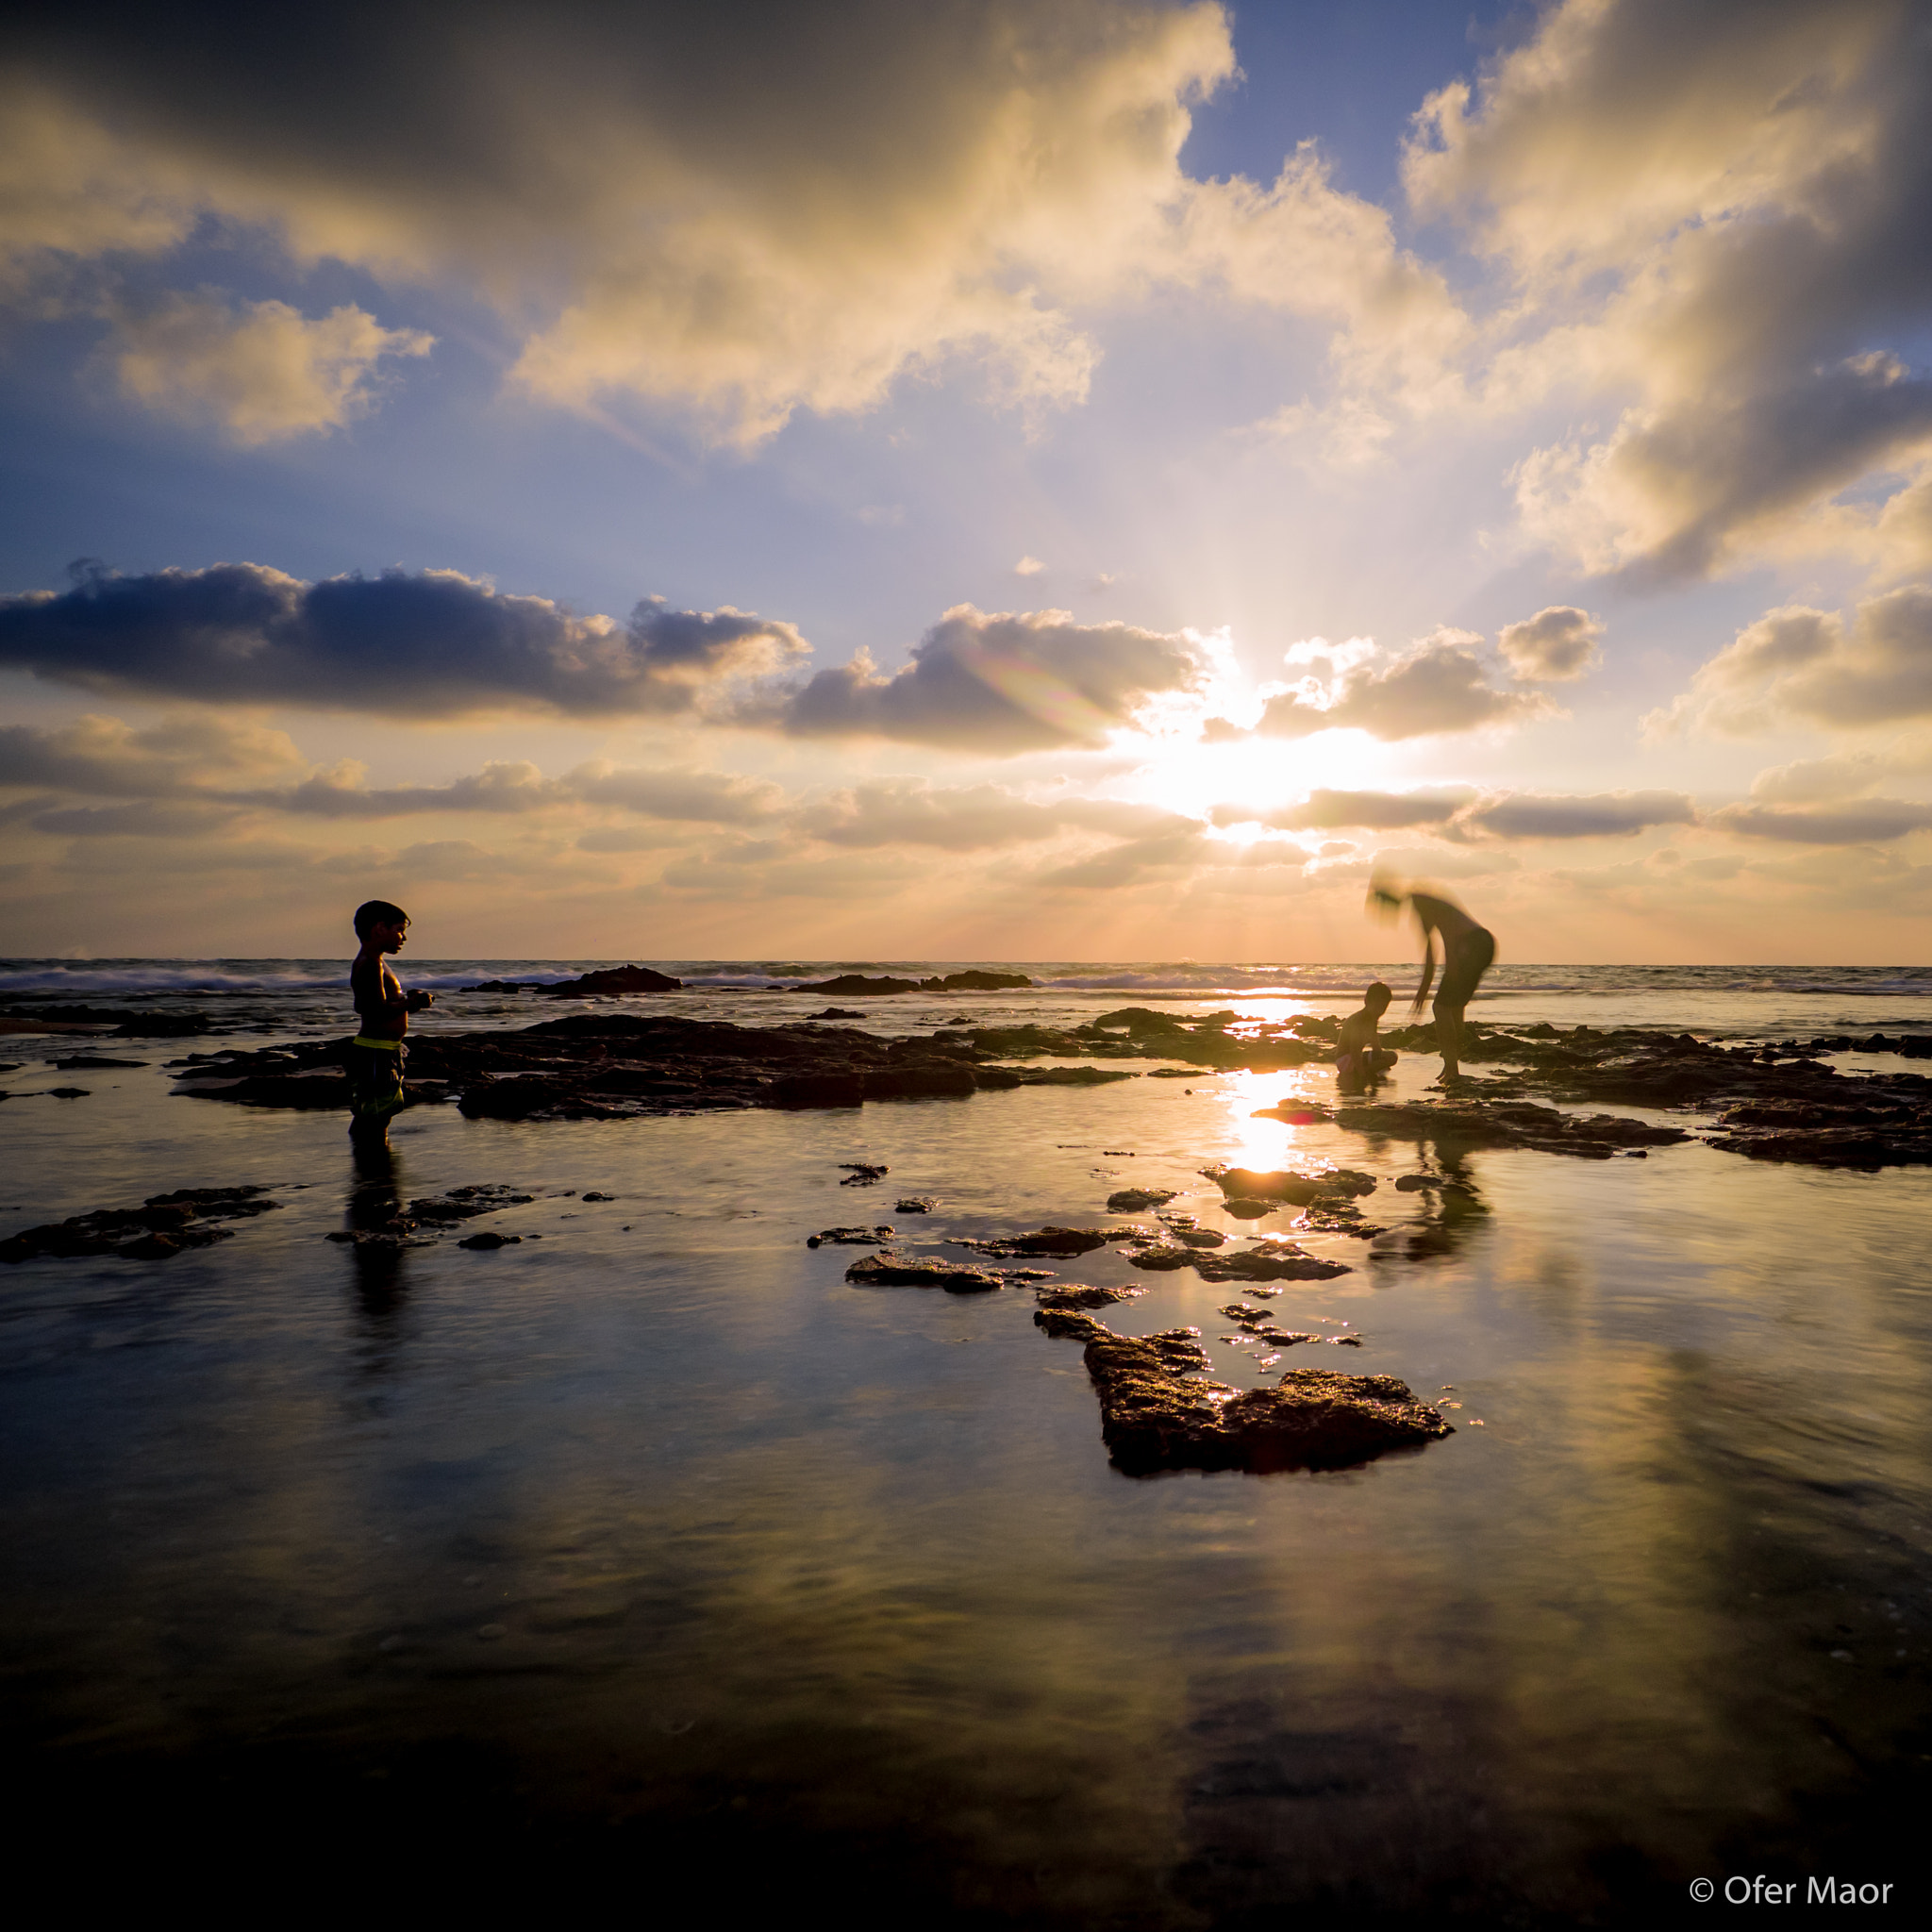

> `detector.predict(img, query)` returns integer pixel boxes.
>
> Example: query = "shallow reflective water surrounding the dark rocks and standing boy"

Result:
[0,964,1932,1926]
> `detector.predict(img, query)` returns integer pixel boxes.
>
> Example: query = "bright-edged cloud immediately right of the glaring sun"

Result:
[1209,628,1561,740]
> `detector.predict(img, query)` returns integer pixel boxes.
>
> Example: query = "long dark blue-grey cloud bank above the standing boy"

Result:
[0,564,809,719]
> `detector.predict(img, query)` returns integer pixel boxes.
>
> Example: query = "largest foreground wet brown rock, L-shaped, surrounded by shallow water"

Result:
[1036,1314,1453,1476]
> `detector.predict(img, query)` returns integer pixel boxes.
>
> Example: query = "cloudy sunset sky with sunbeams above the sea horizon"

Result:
[0,0,1932,966]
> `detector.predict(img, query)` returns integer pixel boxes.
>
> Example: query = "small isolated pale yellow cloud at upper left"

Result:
[110,293,435,448]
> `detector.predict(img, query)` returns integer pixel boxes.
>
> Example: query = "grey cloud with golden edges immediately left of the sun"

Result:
[753,605,1204,756]
